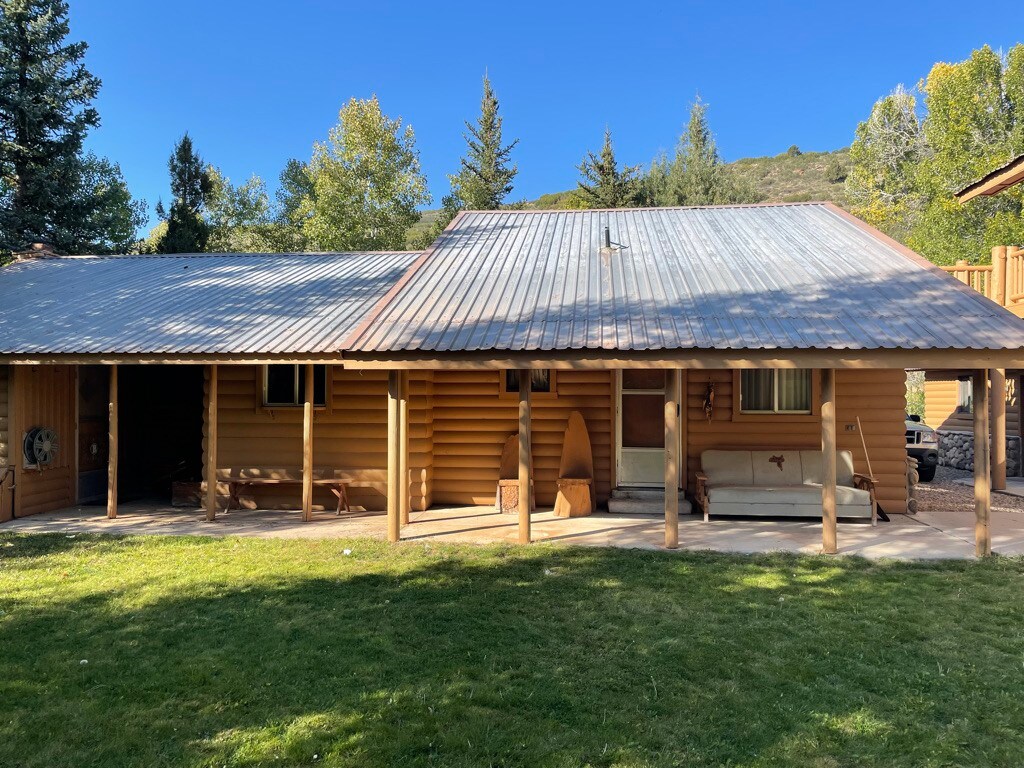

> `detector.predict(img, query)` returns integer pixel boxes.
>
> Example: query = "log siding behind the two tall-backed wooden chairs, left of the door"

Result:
[433,371,614,507]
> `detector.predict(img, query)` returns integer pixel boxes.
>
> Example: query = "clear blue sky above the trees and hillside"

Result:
[71,0,1024,230]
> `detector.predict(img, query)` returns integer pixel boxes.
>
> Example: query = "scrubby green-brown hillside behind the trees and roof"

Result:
[407,147,850,246]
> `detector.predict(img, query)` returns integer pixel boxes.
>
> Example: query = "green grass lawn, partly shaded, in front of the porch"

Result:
[0,535,1024,768]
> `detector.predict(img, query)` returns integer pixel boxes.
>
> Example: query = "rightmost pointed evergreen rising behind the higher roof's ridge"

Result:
[658,98,759,206]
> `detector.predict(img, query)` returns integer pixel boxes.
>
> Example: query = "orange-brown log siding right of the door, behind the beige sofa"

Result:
[685,370,906,513]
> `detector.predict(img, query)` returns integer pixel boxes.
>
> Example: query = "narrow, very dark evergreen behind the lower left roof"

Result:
[157,133,213,253]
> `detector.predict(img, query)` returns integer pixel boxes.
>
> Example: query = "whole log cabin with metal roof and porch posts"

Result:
[0,203,1024,554]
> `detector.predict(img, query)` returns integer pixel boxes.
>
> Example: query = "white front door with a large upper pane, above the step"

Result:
[615,370,665,487]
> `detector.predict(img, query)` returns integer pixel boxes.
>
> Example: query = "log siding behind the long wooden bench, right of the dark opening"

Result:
[203,366,432,510]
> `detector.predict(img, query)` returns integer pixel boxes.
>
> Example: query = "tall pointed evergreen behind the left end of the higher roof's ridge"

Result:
[452,75,519,211]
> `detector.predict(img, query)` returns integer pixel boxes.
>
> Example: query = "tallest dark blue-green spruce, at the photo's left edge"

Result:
[0,0,99,251]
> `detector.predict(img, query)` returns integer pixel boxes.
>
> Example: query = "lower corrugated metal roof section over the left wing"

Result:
[0,253,419,354]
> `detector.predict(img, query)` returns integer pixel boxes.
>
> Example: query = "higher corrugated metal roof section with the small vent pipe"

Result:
[348,204,1024,352]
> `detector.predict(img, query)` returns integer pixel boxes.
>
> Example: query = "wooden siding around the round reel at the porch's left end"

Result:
[8,366,77,517]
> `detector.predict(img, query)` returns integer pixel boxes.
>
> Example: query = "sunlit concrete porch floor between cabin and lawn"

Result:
[0,504,1024,559]
